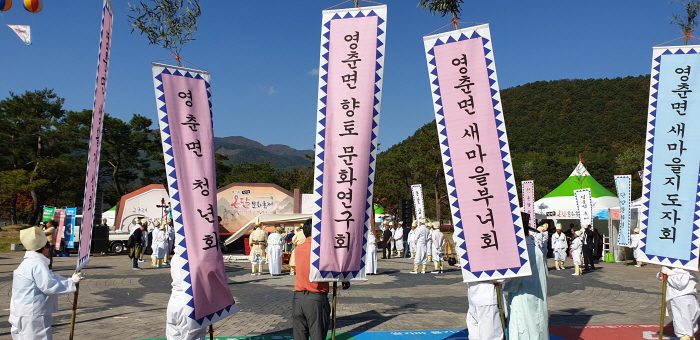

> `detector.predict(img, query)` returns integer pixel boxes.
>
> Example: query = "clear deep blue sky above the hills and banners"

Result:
[0,0,682,151]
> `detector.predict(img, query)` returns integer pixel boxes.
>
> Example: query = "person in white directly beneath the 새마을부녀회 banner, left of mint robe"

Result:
[467,280,507,340]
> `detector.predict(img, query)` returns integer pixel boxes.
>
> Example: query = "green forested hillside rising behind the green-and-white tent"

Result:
[375,76,649,220]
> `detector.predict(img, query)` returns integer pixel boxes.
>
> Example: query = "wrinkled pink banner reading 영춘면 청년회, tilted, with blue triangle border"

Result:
[152,63,239,329]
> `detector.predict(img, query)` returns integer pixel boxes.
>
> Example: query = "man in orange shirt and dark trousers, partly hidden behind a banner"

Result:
[292,219,350,340]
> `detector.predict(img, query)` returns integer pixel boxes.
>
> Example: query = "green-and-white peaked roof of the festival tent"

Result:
[535,163,620,219]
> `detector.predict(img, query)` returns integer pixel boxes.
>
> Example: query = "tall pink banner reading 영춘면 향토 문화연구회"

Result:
[309,5,387,282]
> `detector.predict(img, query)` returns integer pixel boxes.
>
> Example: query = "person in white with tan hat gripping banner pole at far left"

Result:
[9,227,82,340]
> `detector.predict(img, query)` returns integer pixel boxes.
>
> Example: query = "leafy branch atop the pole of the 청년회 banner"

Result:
[127,0,202,60]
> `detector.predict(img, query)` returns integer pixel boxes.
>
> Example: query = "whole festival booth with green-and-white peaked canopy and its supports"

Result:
[535,162,620,256]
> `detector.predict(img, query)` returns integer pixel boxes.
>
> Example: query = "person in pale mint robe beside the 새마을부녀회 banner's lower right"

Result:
[505,230,549,340]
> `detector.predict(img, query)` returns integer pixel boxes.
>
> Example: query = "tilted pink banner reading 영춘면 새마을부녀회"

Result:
[423,24,531,282]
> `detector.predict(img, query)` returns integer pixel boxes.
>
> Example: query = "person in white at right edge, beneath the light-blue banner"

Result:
[656,266,700,340]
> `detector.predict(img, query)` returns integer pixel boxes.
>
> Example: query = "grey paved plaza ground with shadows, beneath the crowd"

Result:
[0,253,684,340]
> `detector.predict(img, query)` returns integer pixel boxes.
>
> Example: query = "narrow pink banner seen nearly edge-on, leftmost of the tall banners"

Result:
[75,0,114,271]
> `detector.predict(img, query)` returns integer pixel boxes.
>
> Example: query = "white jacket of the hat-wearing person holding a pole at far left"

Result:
[10,251,75,316]
